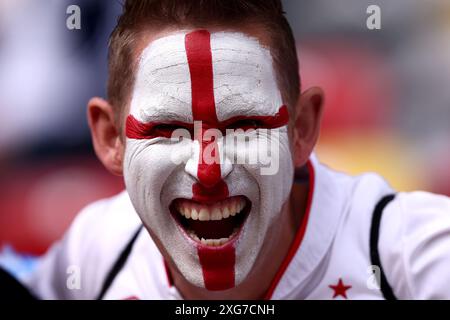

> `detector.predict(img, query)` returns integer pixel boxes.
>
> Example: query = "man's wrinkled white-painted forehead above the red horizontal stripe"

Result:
[130,31,282,122]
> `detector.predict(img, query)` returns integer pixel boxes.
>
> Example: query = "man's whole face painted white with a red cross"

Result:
[124,30,293,290]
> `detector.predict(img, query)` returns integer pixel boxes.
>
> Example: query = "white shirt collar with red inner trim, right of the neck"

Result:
[267,154,348,299]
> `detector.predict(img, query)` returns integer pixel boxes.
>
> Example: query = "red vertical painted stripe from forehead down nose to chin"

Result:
[185,30,236,290]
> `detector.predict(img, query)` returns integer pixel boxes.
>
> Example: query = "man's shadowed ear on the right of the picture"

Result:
[292,87,324,168]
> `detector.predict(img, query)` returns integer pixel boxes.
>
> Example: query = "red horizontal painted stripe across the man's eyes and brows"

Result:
[125,105,289,139]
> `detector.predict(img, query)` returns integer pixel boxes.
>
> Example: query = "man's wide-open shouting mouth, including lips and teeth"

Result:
[170,196,251,247]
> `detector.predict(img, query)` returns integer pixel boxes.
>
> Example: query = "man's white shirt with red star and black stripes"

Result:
[25,156,450,299]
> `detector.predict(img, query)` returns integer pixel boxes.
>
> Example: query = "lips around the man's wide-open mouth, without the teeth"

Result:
[169,195,252,250]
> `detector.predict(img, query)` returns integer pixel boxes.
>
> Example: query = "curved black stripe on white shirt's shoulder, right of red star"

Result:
[370,194,397,300]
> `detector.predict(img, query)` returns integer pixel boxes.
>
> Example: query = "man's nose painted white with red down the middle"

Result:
[185,141,233,188]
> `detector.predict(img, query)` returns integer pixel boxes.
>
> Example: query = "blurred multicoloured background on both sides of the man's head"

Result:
[0,0,450,255]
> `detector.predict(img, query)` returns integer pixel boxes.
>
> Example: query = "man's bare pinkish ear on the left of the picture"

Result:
[87,98,125,175]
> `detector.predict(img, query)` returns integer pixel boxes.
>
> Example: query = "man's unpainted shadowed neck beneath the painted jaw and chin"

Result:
[169,179,308,300]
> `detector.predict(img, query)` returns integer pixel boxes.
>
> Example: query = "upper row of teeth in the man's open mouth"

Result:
[178,198,245,221]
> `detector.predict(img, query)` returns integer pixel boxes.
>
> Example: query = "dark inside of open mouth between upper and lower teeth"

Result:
[189,217,237,239]
